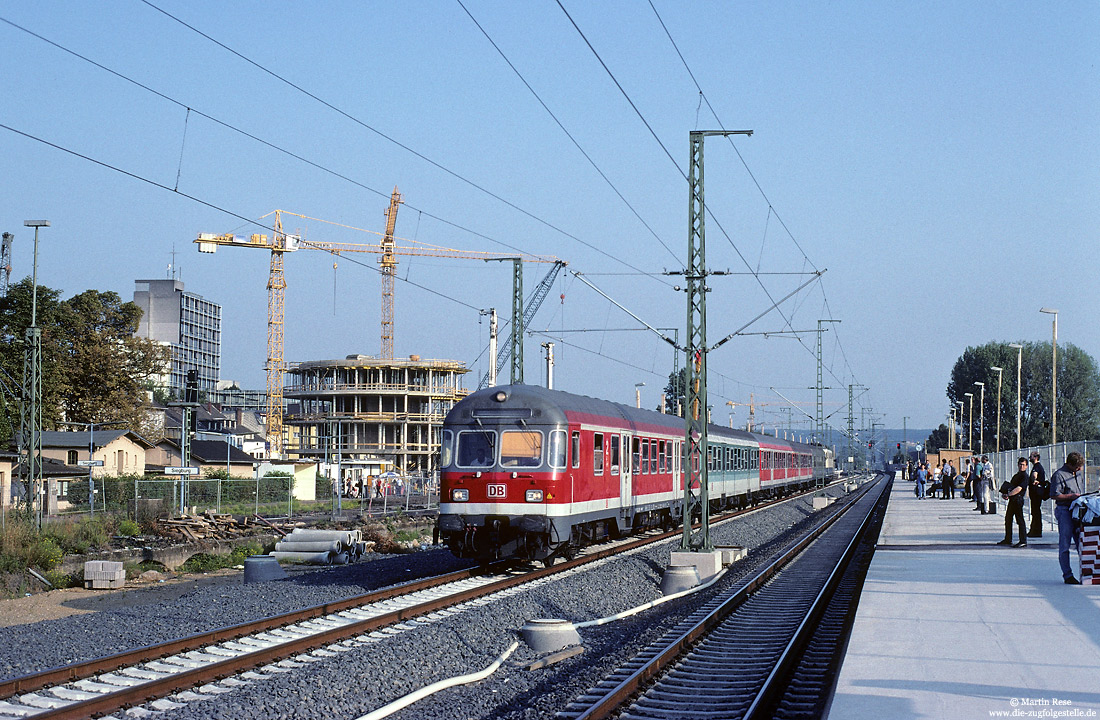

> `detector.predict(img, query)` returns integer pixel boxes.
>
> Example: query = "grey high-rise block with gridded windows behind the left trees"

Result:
[134,279,221,398]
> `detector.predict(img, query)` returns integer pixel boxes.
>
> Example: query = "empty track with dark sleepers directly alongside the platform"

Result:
[558,472,890,720]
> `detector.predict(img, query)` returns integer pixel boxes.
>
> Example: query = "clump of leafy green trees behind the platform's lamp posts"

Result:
[947,342,1100,452]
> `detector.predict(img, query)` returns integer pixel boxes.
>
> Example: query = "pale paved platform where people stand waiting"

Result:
[827,480,1100,720]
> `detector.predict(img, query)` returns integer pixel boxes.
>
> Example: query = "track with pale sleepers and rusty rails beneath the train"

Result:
[0,479,849,719]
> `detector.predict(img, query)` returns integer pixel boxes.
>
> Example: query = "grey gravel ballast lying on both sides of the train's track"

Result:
[0,487,875,720]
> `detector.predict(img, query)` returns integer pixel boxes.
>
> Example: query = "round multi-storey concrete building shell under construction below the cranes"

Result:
[283,355,469,476]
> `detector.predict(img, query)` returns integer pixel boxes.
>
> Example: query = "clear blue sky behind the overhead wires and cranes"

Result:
[0,0,1100,439]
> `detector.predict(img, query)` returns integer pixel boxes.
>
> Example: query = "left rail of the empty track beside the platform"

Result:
[573,472,879,720]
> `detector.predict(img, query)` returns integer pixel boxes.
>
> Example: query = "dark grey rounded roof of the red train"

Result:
[447,385,821,452]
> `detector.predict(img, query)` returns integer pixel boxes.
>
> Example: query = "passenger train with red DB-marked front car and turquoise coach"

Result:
[438,385,835,564]
